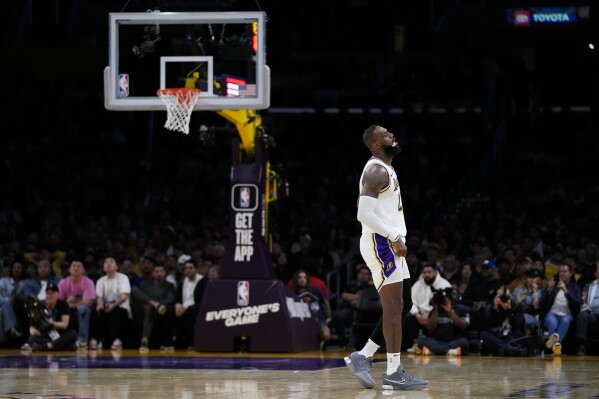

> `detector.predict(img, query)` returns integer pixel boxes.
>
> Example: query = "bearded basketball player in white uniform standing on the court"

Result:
[345,125,428,390]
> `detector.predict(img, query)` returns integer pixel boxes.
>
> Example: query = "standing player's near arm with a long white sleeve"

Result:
[358,164,400,241]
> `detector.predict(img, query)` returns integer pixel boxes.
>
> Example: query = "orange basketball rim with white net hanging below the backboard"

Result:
[157,89,200,134]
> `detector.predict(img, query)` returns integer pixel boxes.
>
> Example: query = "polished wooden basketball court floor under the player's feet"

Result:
[0,350,599,399]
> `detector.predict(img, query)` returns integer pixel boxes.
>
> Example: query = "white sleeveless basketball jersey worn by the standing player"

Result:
[360,157,407,238]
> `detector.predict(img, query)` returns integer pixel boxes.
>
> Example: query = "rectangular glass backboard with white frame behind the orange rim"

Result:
[104,11,270,111]
